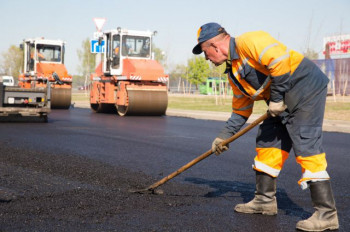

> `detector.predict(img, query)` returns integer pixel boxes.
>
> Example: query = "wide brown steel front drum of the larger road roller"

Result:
[117,90,168,116]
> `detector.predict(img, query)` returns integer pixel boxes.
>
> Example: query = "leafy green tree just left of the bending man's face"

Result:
[187,56,210,89]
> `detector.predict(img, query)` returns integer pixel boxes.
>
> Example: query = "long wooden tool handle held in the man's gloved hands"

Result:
[144,112,270,191]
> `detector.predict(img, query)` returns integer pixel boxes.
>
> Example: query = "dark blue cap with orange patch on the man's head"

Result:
[192,23,225,55]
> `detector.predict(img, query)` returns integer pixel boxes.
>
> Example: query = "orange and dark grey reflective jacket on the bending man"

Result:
[226,31,304,118]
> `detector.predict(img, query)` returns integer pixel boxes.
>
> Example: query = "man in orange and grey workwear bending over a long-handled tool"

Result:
[192,23,339,231]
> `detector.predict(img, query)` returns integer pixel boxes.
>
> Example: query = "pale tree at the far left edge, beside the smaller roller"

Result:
[1,45,23,77]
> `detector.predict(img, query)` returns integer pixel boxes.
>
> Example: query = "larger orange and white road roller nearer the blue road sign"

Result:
[90,28,169,116]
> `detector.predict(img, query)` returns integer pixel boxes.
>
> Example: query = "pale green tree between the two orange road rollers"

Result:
[77,38,96,77]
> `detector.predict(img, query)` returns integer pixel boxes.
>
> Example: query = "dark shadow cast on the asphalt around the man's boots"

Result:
[185,178,311,219]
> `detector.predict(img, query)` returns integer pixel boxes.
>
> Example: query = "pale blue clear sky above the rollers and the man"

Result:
[0,0,350,74]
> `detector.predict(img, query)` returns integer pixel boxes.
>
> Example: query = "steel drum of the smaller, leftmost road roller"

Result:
[51,88,72,109]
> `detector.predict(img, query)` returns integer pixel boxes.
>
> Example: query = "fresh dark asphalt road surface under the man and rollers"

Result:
[0,108,350,232]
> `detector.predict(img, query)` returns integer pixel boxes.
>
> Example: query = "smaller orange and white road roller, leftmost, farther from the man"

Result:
[18,37,72,109]
